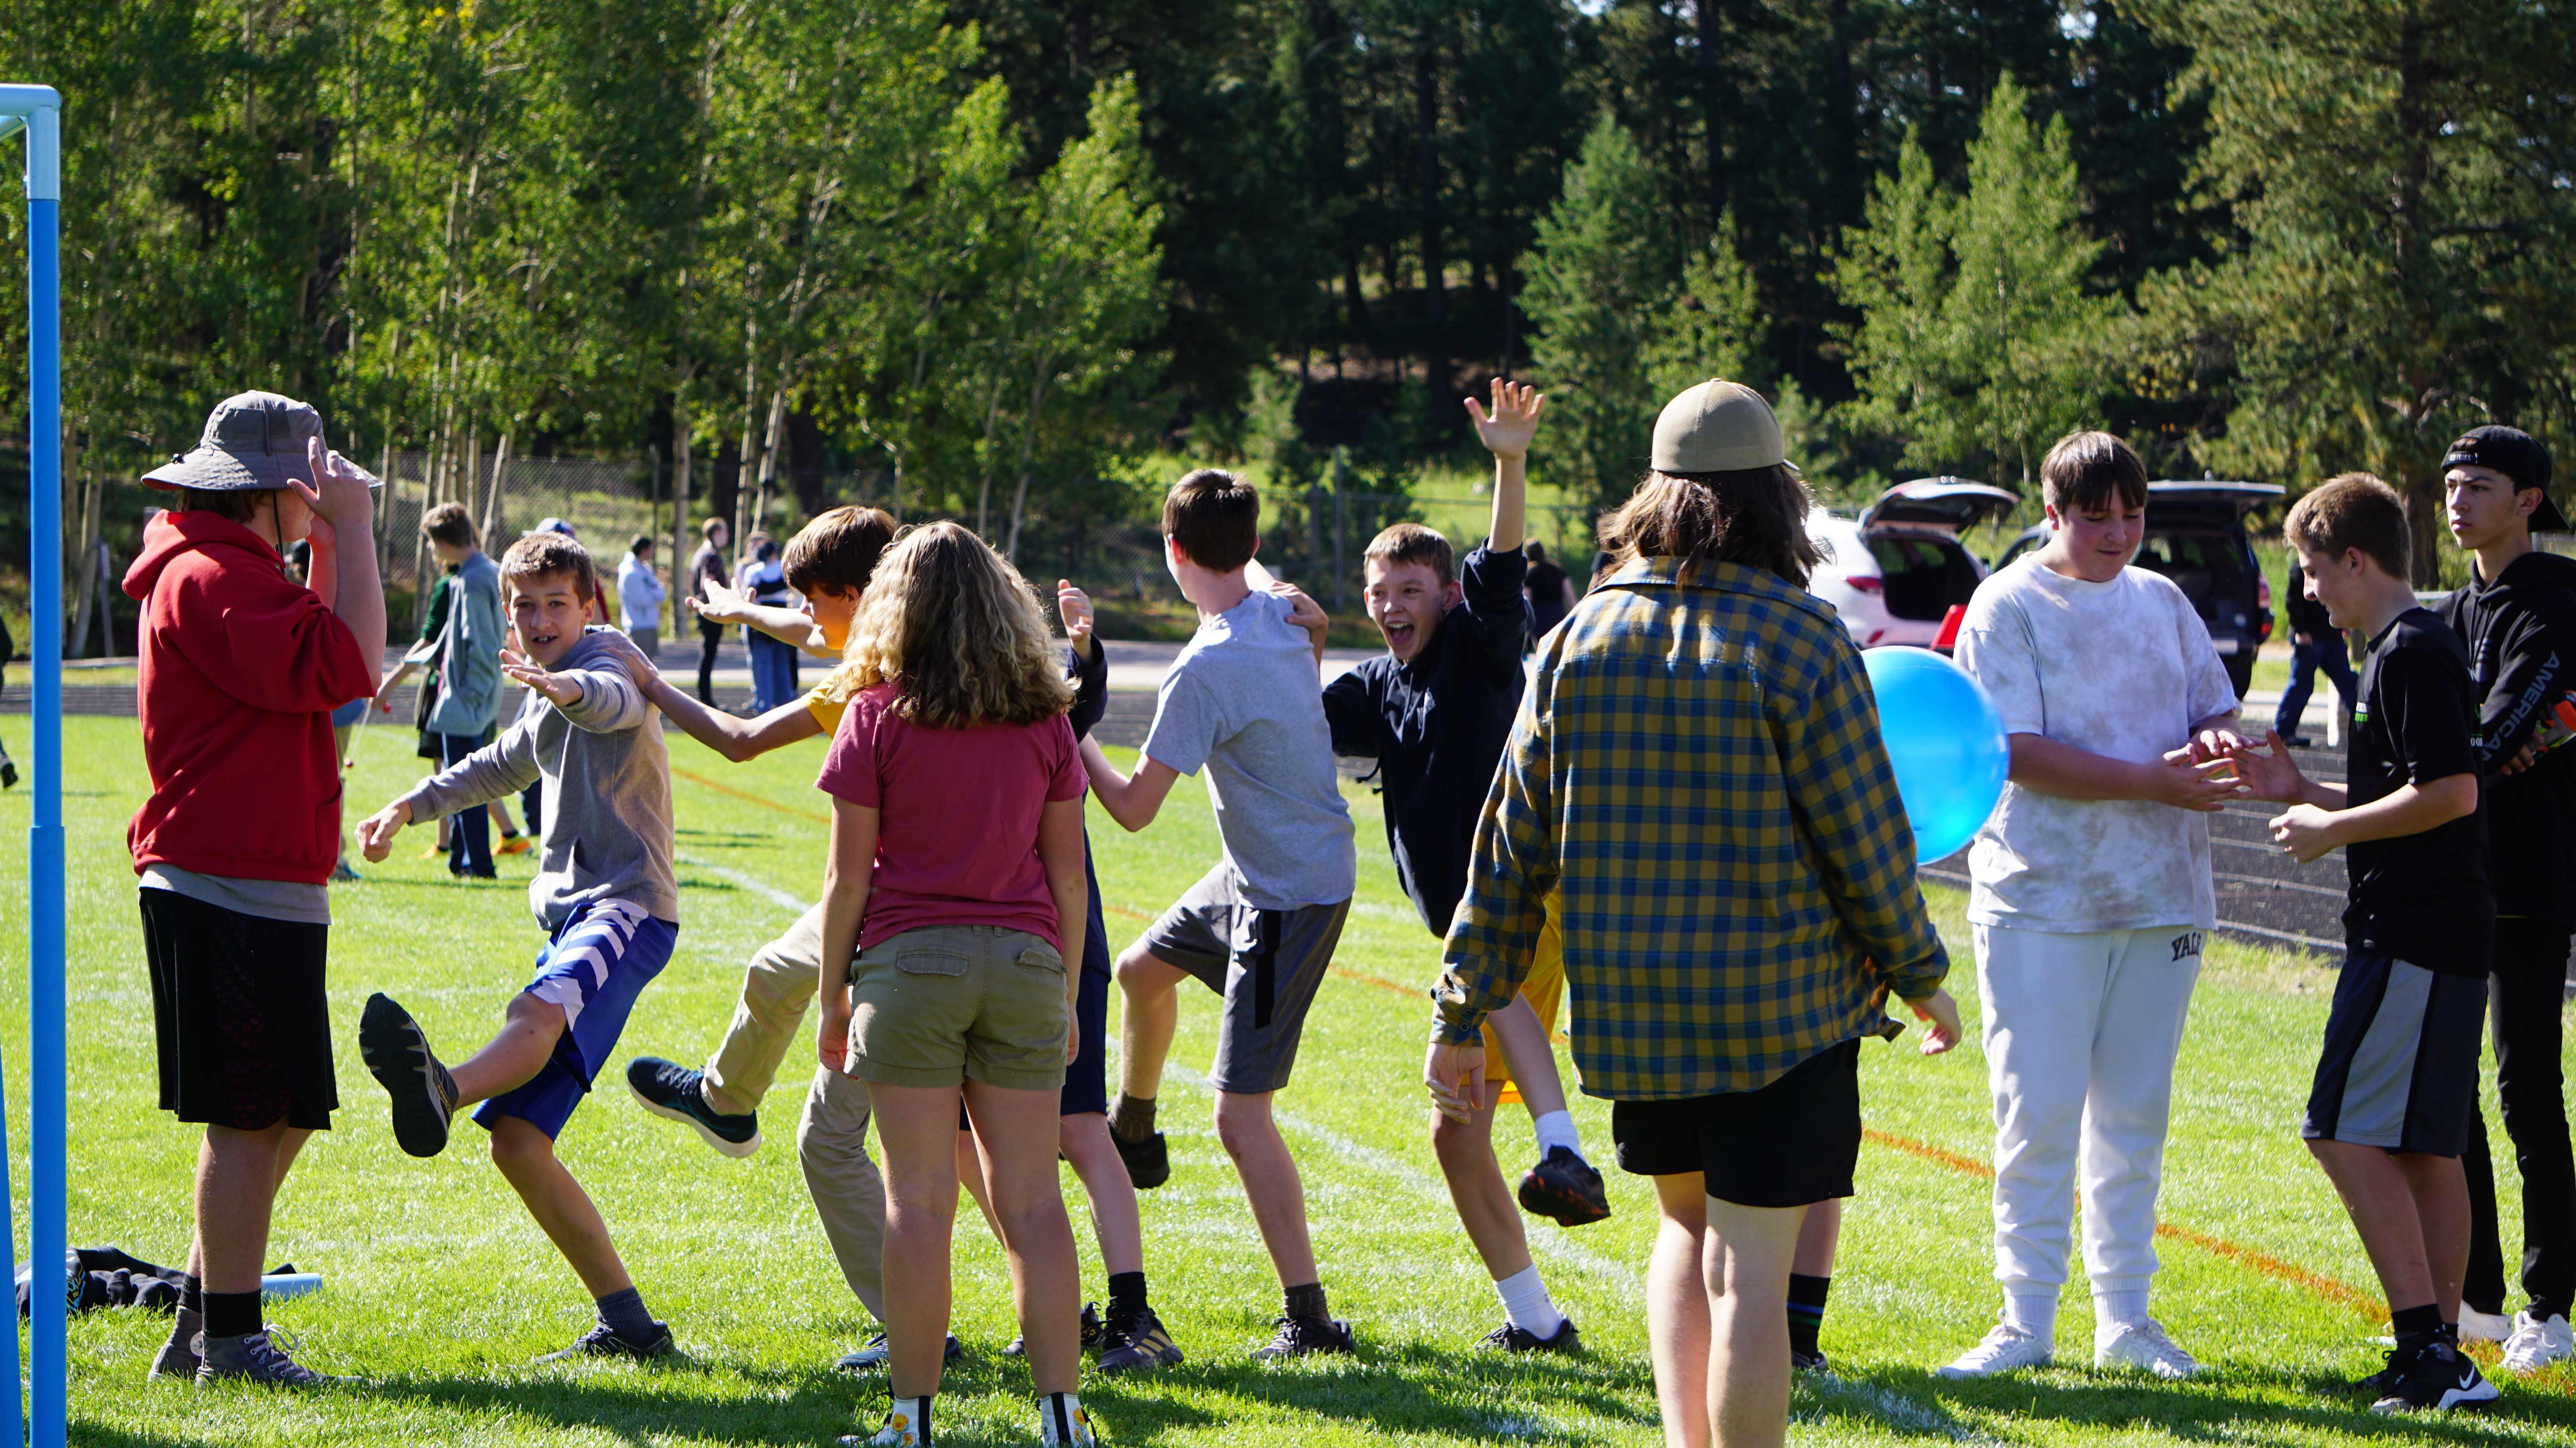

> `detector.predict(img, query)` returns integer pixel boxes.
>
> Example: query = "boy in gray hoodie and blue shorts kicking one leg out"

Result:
[358,533,680,1360]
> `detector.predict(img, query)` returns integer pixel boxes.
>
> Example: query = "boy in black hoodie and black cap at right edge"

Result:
[2437,428,2576,1373]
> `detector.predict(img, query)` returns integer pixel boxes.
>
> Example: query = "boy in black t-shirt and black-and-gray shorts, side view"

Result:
[2231,474,2496,1412]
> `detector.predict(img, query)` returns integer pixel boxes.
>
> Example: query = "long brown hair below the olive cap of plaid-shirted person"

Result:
[1600,466,1824,587]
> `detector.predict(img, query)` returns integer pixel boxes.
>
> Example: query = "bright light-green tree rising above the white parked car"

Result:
[1837,77,2115,484]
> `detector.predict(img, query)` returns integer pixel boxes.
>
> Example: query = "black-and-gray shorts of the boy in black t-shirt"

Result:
[2298,956,2486,1157]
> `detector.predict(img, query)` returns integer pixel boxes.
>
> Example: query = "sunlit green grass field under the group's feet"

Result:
[0,716,2576,1448]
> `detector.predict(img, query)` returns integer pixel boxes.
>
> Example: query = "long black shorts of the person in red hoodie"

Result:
[137,889,340,1131]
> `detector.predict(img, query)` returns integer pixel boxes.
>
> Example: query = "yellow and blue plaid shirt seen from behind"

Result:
[1432,559,1950,1100]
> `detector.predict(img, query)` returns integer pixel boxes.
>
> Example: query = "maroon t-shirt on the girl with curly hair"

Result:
[814,683,1087,951]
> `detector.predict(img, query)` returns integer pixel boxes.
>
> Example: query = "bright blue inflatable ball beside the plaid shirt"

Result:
[1860,647,2012,866]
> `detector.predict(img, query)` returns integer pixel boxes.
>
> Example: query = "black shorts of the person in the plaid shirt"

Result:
[1610,1041,1860,1206]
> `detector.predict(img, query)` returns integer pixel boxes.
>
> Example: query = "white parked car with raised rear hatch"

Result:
[1806,477,2017,649]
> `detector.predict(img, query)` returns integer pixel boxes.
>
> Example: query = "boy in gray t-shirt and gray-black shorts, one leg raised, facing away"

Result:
[1082,469,1358,1358]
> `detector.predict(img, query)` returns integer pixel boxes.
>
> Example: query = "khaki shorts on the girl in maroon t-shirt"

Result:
[850,925,1064,1090]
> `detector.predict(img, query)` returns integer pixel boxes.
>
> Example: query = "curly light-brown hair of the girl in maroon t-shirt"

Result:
[842,523,1074,729]
